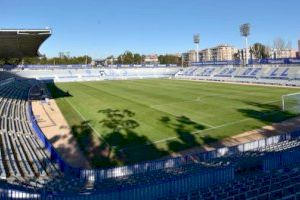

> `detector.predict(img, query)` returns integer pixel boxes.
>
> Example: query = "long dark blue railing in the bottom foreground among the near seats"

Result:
[0,165,234,200]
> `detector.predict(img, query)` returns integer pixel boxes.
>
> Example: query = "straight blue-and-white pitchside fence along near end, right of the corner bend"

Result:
[80,131,300,181]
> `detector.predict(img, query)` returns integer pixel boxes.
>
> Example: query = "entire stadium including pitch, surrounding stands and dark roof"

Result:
[0,26,300,200]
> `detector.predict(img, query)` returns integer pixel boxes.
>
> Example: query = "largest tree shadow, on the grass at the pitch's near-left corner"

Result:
[72,109,168,167]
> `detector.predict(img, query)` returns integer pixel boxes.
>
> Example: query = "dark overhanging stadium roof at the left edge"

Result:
[0,29,51,58]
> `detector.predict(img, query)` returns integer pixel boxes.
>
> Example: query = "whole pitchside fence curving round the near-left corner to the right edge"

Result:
[28,81,300,182]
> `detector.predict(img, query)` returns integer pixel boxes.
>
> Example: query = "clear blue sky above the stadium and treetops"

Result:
[0,0,300,58]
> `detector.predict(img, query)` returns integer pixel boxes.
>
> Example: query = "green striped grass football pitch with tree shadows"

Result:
[48,79,299,167]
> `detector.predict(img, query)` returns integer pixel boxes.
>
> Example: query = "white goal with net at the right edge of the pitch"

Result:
[282,93,300,114]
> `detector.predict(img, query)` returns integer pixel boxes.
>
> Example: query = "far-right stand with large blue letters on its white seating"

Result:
[175,65,300,86]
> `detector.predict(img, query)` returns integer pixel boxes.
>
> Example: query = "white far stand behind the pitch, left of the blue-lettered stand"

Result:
[13,66,180,82]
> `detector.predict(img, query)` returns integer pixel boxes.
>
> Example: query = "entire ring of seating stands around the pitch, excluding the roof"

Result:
[0,63,300,200]
